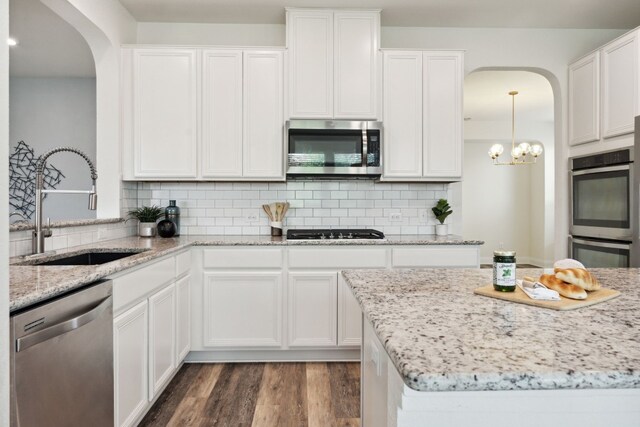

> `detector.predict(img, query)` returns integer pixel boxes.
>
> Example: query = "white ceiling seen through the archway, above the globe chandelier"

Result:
[464,71,553,123]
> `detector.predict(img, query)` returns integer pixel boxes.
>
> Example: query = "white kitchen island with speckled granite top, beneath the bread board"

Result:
[343,269,640,427]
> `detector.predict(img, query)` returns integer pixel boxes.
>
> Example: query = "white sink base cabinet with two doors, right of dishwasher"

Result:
[111,251,191,427]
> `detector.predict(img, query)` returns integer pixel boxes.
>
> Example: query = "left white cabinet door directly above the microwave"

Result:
[287,10,333,119]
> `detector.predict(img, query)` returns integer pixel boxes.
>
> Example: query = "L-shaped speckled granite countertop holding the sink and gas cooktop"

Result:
[9,235,483,312]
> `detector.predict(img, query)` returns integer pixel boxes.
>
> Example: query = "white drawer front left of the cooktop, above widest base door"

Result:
[204,247,282,268]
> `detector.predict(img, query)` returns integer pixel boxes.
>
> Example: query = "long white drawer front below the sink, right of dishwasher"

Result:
[113,257,176,313]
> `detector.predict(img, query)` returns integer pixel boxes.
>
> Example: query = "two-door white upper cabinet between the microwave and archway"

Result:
[382,50,464,181]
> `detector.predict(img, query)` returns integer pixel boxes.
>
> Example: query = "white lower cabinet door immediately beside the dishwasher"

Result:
[113,300,149,426]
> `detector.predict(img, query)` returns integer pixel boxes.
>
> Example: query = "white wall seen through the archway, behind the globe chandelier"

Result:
[462,120,555,266]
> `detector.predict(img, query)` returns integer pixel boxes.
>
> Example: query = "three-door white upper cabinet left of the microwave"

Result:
[122,47,285,181]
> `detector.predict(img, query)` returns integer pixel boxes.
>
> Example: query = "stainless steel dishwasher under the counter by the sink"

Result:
[10,280,113,427]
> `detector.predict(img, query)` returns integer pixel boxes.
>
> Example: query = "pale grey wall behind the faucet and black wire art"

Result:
[9,77,96,221]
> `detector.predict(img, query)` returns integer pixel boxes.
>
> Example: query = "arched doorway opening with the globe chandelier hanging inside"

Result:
[461,70,555,267]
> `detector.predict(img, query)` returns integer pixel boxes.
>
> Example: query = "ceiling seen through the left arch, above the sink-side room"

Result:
[9,0,95,77]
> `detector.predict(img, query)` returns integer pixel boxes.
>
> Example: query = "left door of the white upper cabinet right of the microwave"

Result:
[383,51,422,178]
